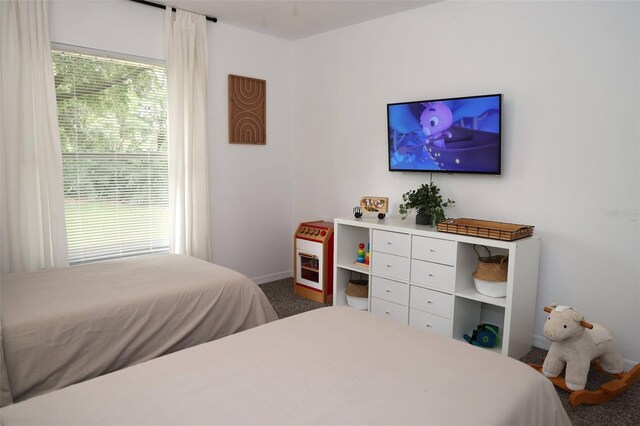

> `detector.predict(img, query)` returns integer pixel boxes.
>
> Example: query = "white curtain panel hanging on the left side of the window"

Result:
[0,0,68,273]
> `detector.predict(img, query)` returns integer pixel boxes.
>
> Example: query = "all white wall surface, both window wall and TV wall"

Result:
[51,0,640,362]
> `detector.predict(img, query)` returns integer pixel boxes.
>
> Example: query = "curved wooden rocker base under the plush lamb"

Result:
[529,360,640,407]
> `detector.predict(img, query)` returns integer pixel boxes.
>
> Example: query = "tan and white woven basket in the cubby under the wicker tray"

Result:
[472,244,509,297]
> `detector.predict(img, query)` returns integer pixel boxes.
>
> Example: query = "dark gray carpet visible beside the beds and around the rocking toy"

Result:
[260,278,640,426]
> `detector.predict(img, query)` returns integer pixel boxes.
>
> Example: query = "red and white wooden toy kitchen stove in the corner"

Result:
[293,221,333,304]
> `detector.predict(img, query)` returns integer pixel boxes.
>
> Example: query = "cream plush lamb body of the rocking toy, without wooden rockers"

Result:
[542,305,624,391]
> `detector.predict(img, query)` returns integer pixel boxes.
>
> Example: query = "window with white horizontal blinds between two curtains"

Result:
[53,50,169,264]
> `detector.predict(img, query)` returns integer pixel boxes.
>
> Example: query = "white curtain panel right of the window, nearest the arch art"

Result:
[165,7,211,261]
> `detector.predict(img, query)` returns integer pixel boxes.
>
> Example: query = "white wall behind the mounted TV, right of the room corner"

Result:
[292,1,640,362]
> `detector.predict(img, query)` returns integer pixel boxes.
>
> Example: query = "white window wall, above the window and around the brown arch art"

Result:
[50,0,293,283]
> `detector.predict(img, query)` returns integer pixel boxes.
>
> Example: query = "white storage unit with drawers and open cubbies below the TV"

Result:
[333,217,540,358]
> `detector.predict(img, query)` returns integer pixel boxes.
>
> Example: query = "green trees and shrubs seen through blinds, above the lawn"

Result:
[53,52,167,203]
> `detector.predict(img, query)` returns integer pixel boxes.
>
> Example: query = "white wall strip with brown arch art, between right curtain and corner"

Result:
[209,23,293,283]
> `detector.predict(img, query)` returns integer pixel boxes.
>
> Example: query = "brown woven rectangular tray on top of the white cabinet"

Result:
[438,218,534,241]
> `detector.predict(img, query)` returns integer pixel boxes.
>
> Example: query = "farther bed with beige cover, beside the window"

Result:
[0,255,277,403]
